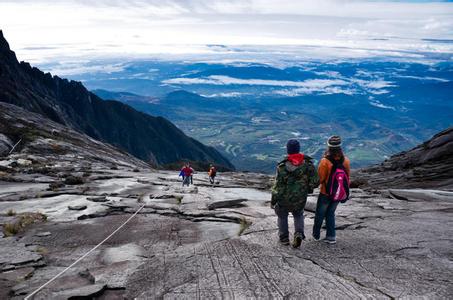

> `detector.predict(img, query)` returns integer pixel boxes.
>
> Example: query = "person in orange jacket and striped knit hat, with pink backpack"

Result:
[313,135,351,244]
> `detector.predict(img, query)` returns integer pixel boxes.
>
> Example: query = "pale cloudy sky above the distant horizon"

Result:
[0,0,453,62]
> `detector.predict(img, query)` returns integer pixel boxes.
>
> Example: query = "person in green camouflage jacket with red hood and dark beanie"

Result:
[271,139,319,248]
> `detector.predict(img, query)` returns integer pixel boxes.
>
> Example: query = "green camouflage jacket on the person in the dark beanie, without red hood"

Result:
[271,156,319,211]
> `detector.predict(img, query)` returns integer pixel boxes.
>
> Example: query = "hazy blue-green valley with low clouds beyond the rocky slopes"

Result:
[83,58,453,174]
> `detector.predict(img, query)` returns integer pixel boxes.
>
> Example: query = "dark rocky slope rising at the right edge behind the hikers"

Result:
[357,127,453,189]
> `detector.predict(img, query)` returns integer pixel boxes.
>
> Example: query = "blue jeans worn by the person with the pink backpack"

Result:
[313,194,339,239]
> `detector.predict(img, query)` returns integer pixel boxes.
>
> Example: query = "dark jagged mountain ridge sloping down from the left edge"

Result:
[0,31,234,169]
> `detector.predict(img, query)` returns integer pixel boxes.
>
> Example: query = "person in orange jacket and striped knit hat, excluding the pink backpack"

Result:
[313,135,351,244]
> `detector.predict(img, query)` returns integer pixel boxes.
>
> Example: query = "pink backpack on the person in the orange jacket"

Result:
[326,161,349,203]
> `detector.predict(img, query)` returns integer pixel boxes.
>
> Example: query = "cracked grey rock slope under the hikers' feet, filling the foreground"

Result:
[0,165,453,299]
